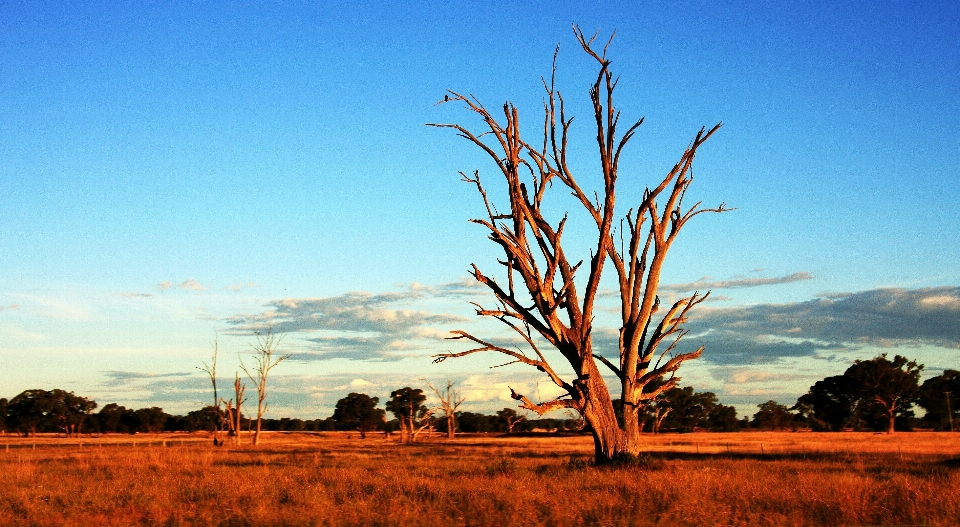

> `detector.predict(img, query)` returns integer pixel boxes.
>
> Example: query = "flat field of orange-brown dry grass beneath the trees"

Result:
[0,432,960,526]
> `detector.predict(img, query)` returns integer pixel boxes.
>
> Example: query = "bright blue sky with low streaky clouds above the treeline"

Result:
[0,2,960,417]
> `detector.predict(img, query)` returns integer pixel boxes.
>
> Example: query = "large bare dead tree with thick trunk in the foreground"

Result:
[432,26,730,463]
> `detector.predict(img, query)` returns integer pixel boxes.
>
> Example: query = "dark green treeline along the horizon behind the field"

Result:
[0,354,960,436]
